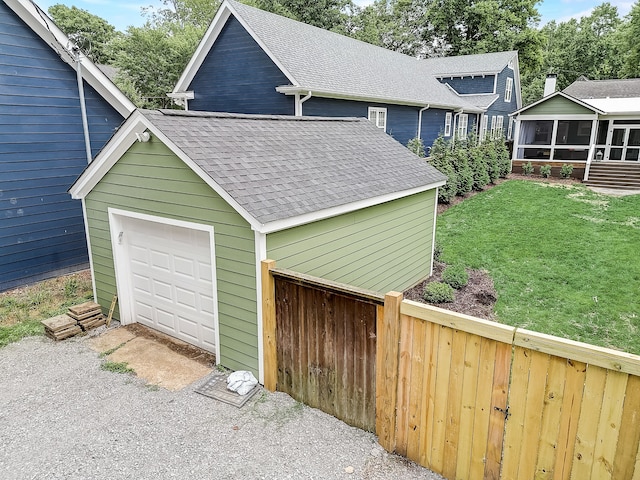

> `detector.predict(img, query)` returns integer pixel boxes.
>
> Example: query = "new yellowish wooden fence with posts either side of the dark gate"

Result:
[263,264,640,480]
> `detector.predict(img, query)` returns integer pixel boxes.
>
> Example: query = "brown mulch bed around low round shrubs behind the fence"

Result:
[404,262,498,320]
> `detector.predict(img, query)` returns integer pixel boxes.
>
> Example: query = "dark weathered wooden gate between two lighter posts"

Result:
[272,271,383,431]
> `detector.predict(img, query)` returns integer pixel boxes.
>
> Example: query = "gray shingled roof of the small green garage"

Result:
[141,110,446,224]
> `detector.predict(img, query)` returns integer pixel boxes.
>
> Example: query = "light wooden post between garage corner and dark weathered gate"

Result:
[261,260,278,392]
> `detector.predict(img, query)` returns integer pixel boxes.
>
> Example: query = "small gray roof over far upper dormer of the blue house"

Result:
[423,50,518,78]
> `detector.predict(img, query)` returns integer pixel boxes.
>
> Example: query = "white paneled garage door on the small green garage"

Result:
[116,217,216,353]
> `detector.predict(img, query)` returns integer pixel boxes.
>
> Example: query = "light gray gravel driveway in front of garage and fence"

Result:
[0,337,442,480]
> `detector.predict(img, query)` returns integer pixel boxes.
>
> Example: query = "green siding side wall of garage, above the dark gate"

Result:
[267,189,436,293]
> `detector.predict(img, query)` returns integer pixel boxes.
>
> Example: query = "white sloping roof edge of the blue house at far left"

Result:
[3,0,136,117]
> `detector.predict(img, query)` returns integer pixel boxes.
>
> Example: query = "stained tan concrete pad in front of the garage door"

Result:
[107,337,212,391]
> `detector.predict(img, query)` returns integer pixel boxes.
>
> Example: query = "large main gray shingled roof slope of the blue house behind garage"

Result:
[229,0,482,111]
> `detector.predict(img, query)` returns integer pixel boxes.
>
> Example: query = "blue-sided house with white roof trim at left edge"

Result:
[0,0,135,291]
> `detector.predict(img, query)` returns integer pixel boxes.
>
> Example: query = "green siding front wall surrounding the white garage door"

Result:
[86,140,258,376]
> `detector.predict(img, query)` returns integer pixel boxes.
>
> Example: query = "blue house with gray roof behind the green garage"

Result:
[169,0,521,147]
